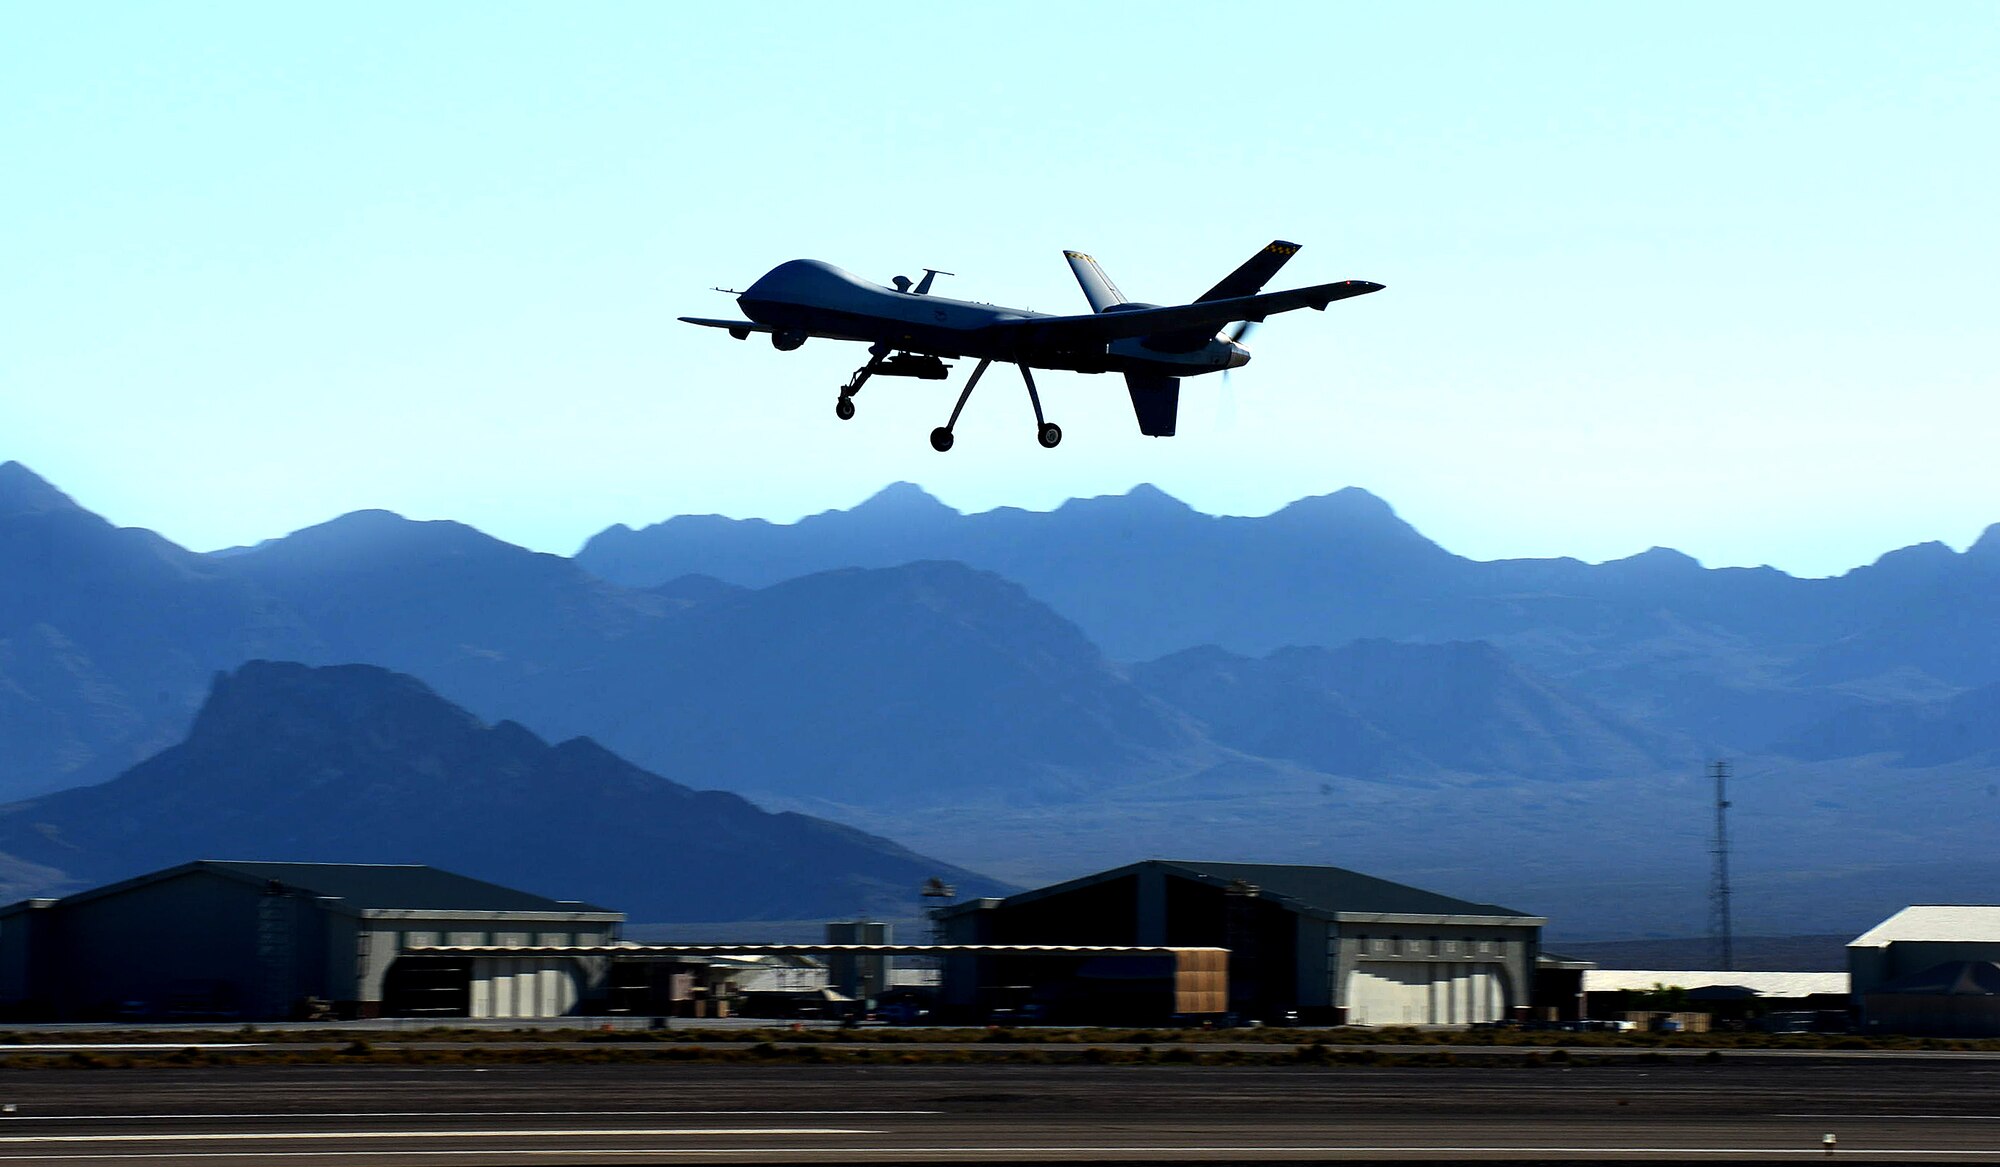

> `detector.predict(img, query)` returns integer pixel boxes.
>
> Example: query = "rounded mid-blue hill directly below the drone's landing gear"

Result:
[536,562,1216,807]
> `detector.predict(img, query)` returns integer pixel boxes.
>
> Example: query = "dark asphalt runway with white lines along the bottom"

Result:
[0,1059,2000,1167]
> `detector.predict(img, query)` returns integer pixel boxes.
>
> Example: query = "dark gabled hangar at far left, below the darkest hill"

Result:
[0,859,624,1019]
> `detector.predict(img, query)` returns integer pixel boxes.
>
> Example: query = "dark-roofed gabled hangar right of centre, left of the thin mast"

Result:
[936,859,1548,1025]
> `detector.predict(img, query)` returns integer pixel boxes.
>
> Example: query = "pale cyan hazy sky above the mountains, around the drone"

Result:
[0,0,2000,574]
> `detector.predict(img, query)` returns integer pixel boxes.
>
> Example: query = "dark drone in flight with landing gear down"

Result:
[680,240,1382,454]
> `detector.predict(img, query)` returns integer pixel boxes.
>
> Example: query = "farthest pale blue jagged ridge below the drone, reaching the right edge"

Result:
[576,484,2000,753]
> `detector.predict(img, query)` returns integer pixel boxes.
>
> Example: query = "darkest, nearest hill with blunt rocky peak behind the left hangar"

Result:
[0,661,1002,921]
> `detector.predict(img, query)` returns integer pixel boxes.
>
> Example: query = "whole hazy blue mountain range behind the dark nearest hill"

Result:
[0,464,2000,935]
